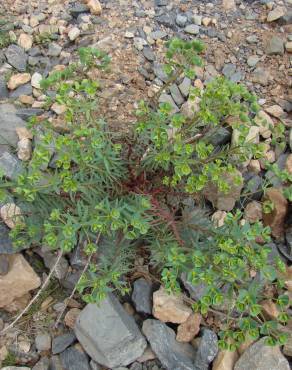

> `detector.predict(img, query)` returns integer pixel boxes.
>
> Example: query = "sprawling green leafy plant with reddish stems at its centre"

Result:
[1,39,289,349]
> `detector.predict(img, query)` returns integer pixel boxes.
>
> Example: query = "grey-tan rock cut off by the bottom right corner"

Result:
[234,337,290,370]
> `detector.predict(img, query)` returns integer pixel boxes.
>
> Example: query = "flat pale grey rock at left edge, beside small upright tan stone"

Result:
[0,104,26,154]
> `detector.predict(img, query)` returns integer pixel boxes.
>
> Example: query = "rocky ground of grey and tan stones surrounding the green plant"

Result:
[0,0,292,370]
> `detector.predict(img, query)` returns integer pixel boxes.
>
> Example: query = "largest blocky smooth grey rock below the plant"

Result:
[75,294,147,368]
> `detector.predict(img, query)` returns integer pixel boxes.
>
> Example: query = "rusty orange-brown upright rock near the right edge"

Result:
[263,188,288,238]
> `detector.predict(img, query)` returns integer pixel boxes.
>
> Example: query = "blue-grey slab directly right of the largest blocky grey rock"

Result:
[142,319,199,370]
